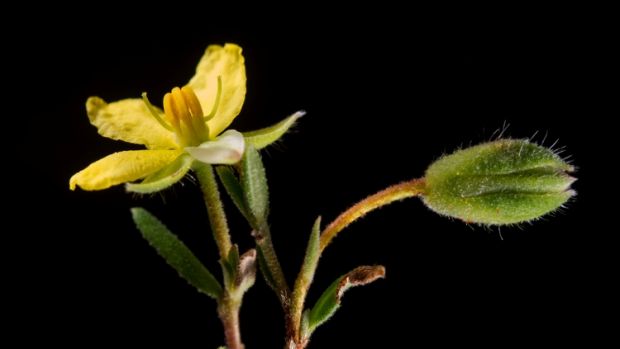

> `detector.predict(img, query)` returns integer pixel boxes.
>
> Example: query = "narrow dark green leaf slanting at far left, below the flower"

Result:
[131,207,222,299]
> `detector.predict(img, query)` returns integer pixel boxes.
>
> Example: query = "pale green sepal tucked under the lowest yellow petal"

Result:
[125,154,194,194]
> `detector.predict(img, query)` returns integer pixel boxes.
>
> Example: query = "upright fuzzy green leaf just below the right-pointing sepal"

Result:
[241,145,269,224]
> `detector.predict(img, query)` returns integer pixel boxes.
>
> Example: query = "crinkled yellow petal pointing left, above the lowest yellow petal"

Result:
[86,97,178,149]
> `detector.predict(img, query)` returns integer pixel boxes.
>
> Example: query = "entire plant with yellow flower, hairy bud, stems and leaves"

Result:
[69,44,575,349]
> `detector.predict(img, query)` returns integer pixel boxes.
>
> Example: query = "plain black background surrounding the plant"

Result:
[9,8,611,348]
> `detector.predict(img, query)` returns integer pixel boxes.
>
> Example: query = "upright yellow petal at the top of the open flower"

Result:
[188,44,246,138]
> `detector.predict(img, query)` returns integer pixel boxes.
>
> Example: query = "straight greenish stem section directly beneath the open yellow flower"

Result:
[194,162,232,260]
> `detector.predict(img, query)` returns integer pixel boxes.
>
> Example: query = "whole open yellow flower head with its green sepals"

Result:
[69,44,304,193]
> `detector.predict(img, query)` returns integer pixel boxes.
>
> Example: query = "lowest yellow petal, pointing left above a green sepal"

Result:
[69,150,182,190]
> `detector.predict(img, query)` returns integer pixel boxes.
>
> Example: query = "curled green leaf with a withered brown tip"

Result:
[302,265,385,338]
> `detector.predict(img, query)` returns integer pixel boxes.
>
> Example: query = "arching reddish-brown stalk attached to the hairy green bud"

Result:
[321,178,425,252]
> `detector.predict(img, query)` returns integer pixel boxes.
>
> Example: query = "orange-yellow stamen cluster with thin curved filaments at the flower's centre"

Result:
[142,77,222,147]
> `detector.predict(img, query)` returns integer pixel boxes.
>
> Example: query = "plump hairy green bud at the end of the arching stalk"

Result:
[422,139,575,225]
